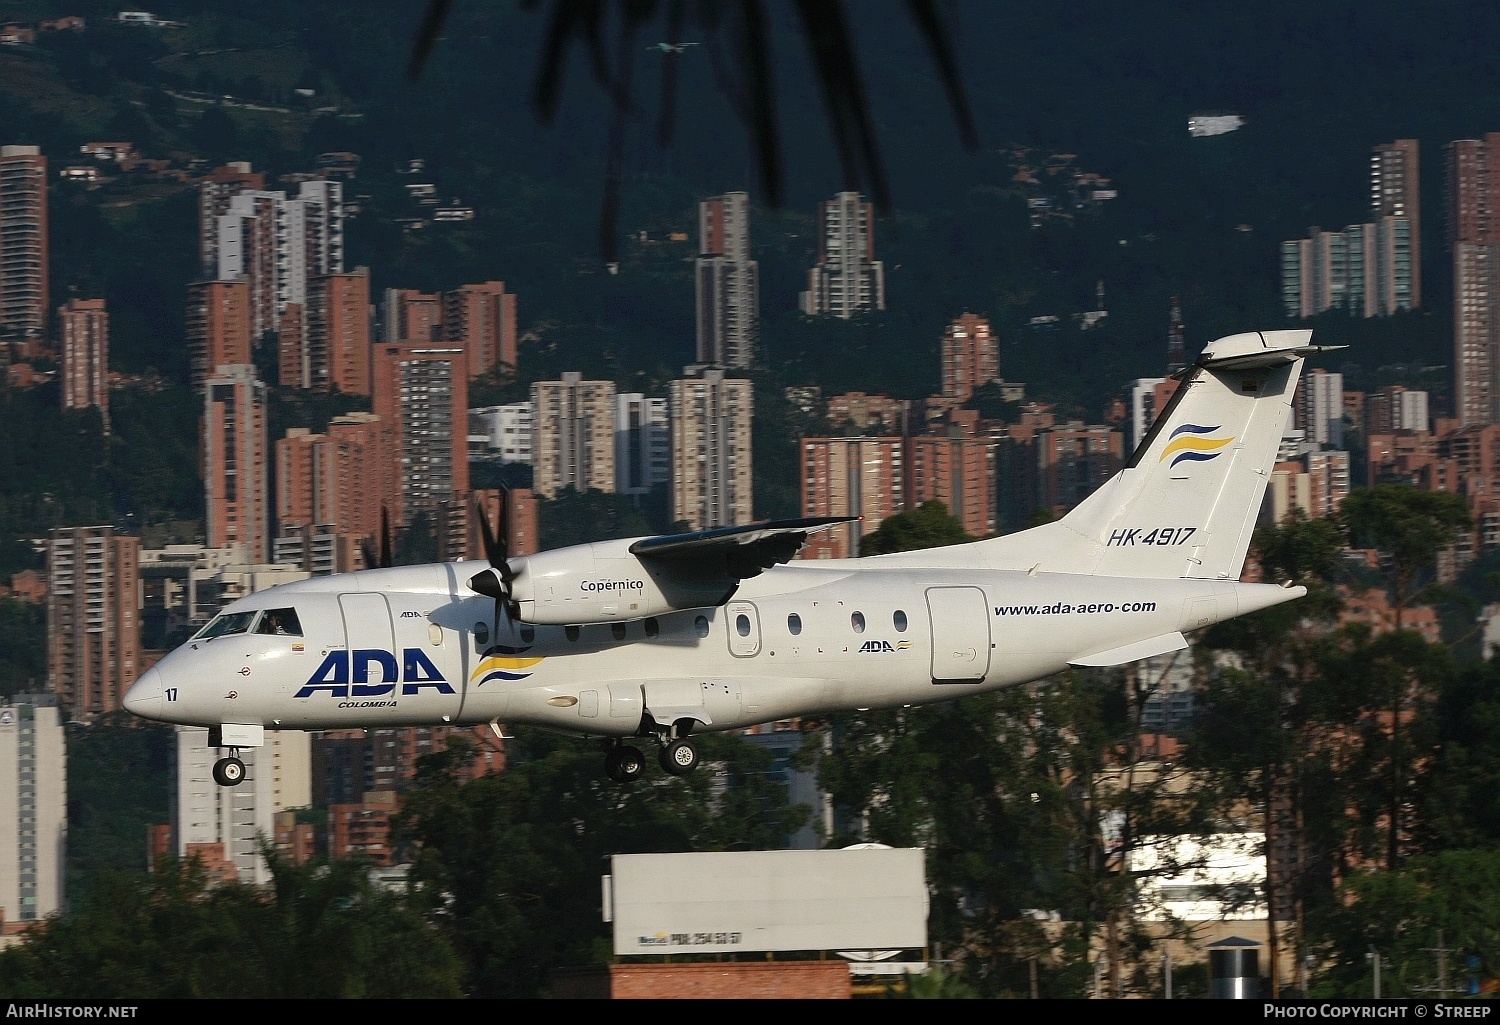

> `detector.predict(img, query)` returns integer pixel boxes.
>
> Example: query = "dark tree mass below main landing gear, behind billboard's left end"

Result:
[393,731,807,998]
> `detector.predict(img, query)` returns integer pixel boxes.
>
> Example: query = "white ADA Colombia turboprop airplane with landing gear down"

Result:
[125,330,1323,786]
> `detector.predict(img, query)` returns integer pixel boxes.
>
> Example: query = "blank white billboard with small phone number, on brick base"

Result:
[603,846,927,954]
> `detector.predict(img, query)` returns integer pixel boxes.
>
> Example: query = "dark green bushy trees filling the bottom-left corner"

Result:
[0,849,462,999]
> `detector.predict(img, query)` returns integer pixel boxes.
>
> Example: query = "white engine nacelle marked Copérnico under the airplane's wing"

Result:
[510,537,740,626]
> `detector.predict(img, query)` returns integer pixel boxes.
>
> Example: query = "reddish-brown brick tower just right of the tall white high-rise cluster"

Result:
[294,267,371,395]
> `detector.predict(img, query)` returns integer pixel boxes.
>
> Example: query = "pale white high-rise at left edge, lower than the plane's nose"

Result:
[0,693,68,924]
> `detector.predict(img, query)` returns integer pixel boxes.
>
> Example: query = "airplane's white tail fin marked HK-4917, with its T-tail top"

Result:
[876,330,1323,579]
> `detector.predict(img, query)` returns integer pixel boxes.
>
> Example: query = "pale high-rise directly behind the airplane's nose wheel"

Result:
[171,726,312,885]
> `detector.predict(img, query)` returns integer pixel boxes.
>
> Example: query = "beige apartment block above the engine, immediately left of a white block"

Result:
[531,372,615,498]
